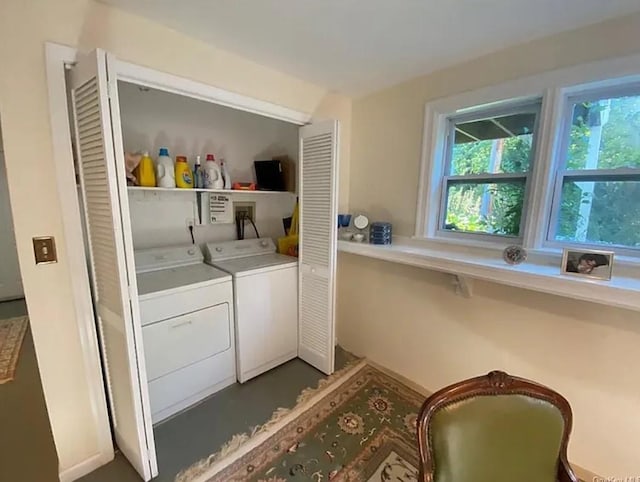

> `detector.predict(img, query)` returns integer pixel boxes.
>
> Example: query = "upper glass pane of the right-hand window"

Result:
[567,95,640,169]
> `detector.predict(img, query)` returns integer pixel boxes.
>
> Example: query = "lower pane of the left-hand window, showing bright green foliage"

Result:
[444,179,525,236]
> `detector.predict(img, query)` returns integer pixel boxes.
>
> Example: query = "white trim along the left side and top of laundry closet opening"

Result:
[45,42,311,482]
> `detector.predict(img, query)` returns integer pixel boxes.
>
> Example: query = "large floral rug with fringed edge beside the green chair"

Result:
[176,361,425,482]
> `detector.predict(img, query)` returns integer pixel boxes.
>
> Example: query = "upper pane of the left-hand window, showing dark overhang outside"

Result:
[449,113,536,176]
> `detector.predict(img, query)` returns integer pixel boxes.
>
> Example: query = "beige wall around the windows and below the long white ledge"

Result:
[338,15,640,477]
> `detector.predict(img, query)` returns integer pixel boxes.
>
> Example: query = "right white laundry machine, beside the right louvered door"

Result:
[205,238,298,383]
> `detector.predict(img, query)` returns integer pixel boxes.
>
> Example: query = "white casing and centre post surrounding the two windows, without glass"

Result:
[413,55,640,262]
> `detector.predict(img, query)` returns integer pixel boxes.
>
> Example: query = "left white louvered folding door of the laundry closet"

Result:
[71,50,158,481]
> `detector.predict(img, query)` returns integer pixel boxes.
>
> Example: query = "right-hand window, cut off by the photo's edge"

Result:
[549,85,640,248]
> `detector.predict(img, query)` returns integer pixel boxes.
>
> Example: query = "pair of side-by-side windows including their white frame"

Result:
[416,68,640,258]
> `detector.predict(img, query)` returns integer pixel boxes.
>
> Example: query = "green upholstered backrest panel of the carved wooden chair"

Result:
[430,394,564,482]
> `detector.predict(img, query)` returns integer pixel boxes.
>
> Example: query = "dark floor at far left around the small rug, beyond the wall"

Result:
[0,300,58,482]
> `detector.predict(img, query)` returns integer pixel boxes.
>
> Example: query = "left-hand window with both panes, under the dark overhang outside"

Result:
[438,101,541,238]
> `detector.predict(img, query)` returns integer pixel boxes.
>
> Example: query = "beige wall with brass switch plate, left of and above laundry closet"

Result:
[0,0,350,470]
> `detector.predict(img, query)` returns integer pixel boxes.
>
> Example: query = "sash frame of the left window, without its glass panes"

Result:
[436,98,542,243]
